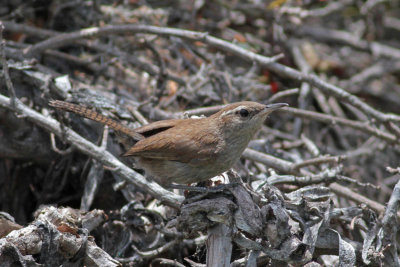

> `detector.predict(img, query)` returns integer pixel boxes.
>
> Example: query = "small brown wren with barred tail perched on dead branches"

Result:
[49,100,288,185]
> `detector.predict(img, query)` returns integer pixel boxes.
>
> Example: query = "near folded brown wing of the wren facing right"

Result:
[123,121,221,164]
